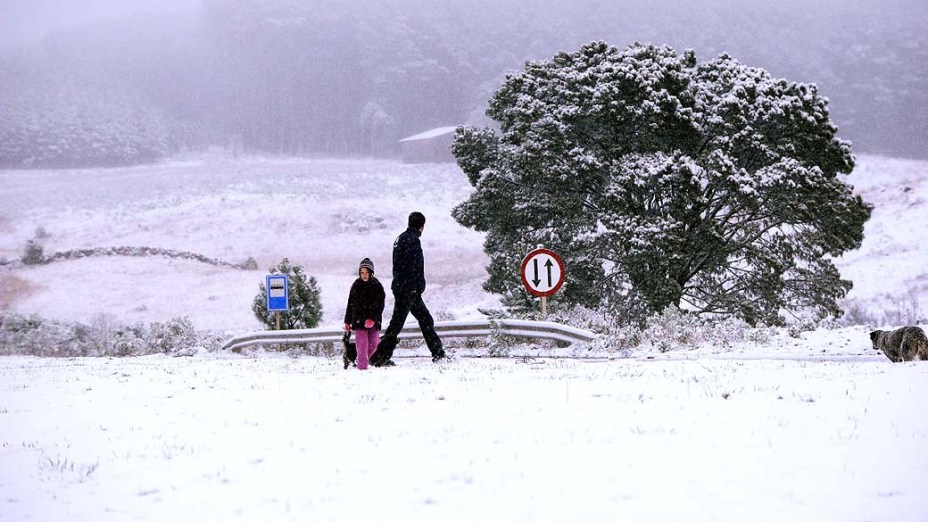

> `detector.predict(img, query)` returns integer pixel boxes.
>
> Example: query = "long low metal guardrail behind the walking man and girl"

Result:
[222,319,598,352]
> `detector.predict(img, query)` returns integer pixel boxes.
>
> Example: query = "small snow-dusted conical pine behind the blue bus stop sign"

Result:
[251,258,322,330]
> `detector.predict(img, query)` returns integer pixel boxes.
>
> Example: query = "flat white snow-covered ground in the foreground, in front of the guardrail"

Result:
[0,348,928,522]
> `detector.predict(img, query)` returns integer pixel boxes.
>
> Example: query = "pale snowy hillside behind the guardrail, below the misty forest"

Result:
[0,150,928,333]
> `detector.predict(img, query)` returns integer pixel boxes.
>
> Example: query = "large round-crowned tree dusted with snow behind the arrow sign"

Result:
[453,42,871,324]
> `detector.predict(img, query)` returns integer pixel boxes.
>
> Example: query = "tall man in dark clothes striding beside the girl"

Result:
[371,212,445,366]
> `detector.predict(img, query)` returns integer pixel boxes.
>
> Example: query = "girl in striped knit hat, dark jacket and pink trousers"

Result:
[345,257,384,370]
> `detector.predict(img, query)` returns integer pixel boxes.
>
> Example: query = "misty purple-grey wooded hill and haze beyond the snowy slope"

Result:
[0,0,928,167]
